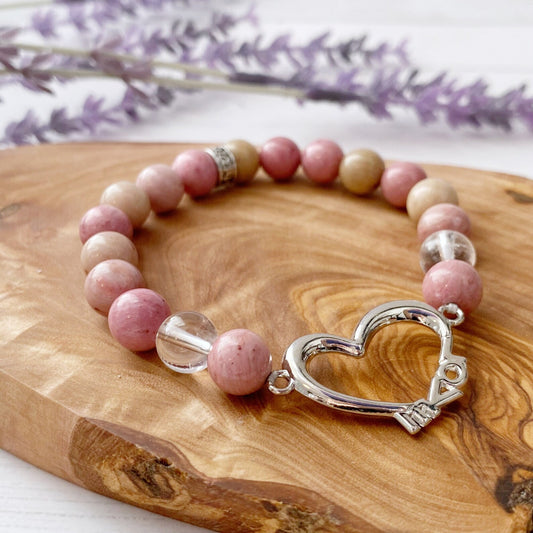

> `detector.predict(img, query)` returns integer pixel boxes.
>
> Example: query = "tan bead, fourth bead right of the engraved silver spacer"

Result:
[339,149,385,195]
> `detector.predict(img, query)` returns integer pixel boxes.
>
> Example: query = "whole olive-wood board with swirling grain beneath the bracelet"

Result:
[0,144,533,533]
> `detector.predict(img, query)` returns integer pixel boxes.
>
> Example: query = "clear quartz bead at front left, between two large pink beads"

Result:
[155,311,217,374]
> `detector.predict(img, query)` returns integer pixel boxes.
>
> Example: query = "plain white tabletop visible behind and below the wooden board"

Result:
[0,0,533,533]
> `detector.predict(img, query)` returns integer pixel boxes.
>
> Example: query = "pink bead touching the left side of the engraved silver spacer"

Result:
[172,150,218,197]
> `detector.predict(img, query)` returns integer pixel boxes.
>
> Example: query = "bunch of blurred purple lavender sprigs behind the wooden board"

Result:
[0,0,533,144]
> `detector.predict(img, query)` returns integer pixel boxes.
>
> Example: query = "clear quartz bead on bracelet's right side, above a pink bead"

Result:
[420,230,476,272]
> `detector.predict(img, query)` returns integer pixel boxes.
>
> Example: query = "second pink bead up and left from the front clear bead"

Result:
[85,259,145,315]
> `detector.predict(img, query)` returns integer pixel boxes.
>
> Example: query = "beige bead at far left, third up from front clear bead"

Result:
[81,231,139,272]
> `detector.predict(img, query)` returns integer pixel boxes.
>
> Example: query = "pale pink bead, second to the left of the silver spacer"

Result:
[135,164,184,213]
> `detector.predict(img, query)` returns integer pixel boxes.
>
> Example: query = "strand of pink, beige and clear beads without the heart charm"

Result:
[79,137,482,395]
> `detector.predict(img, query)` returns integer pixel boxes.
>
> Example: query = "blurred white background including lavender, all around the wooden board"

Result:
[0,0,533,533]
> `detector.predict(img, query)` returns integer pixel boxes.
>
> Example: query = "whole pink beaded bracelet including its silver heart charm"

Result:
[79,137,482,434]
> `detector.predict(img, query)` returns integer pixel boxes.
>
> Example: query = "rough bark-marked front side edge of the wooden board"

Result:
[0,372,379,533]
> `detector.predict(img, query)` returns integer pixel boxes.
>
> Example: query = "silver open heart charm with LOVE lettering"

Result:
[268,300,468,434]
